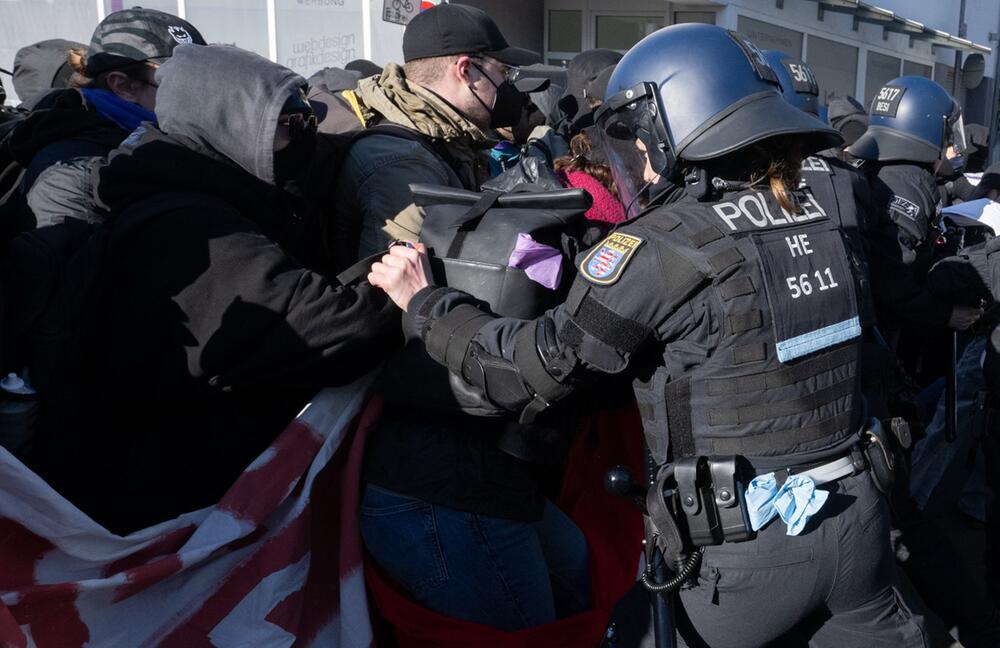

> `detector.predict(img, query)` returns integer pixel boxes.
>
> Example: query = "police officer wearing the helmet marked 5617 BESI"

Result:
[848,76,982,335]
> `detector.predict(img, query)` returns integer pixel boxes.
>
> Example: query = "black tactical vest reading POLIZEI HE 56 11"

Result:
[624,189,861,468]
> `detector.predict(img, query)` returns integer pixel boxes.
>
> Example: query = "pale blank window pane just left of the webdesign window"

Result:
[186,0,268,56]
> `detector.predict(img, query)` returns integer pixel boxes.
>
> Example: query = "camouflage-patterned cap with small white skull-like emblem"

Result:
[87,7,205,76]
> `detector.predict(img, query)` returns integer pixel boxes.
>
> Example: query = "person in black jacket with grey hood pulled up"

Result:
[25,45,399,533]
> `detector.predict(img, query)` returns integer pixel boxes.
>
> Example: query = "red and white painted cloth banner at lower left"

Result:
[0,380,377,648]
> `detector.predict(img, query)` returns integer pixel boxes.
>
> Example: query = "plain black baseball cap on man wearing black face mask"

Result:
[403,3,541,66]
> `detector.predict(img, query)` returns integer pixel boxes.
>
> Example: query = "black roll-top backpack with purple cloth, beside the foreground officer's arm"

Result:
[381,185,592,416]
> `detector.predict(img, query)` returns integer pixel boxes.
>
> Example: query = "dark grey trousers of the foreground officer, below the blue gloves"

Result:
[677,471,930,648]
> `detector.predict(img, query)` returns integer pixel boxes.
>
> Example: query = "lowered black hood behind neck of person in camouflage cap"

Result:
[6,90,128,166]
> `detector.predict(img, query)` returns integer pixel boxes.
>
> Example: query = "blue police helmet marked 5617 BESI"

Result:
[848,76,965,162]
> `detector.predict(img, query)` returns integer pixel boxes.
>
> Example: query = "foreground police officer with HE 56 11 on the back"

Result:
[369,24,926,648]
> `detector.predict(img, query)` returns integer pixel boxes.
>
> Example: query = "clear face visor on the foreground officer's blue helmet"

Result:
[596,83,670,217]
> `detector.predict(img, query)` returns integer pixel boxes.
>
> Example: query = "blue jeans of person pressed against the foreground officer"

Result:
[361,484,590,631]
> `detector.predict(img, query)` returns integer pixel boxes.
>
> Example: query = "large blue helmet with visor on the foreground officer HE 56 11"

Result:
[595,23,843,215]
